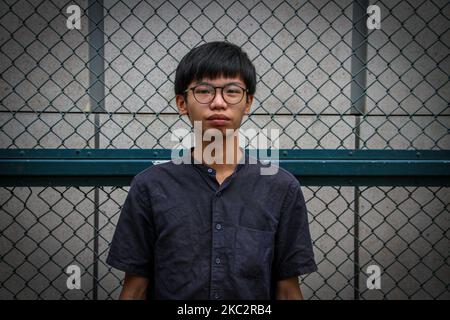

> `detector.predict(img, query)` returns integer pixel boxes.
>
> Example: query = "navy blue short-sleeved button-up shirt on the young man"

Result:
[107,149,317,299]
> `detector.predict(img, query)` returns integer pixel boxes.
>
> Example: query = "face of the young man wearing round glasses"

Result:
[176,77,253,134]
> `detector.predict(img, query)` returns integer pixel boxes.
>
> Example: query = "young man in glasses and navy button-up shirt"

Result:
[107,42,317,299]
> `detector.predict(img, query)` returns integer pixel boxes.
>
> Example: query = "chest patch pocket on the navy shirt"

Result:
[234,226,275,280]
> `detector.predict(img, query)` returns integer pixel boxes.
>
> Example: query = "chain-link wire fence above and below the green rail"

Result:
[0,0,450,299]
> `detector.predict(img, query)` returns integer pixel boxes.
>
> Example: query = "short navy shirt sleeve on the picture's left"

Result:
[106,177,154,278]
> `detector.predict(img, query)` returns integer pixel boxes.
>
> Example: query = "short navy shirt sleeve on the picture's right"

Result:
[274,180,317,281]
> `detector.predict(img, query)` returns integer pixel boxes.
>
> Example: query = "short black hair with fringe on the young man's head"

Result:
[175,41,256,95]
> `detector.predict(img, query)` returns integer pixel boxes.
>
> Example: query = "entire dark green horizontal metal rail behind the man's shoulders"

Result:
[0,149,450,187]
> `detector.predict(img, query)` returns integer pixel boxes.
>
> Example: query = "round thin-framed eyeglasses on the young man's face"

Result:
[184,83,248,104]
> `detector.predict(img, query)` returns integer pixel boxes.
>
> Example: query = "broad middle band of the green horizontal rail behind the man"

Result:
[0,159,450,177]
